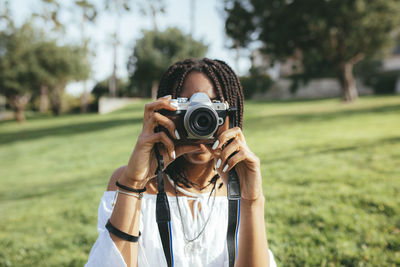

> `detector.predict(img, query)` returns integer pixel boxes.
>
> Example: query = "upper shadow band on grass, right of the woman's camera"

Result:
[244,105,400,130]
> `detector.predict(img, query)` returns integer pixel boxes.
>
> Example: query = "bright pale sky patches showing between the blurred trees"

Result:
[10,0,250,94]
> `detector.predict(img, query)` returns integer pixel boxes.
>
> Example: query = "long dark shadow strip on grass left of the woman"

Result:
[0,118,142,145]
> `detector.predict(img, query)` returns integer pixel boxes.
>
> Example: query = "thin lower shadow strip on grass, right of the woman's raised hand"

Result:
[263,136,400,164]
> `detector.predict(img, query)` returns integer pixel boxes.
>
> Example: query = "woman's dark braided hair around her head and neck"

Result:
[157,58,243,188]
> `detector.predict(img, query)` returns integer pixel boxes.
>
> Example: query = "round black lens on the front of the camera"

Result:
[188,107,218,138]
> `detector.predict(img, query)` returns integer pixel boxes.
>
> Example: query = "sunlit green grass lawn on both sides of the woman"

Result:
[0,96,400,266]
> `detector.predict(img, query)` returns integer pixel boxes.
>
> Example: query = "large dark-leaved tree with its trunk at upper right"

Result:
[225,0,400,102]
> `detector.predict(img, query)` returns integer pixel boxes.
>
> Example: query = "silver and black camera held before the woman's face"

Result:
[158,93,236,144]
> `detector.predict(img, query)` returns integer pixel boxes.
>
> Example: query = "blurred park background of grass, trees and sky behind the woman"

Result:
[0,0,400,266]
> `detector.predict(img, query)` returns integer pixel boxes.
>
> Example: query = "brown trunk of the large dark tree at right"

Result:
[338,62,358,103]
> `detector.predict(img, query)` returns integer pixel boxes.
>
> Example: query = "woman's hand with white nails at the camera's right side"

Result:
[207,127,263,200]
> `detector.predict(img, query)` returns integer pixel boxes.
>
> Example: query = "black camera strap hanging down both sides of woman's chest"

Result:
[154,108,240,267]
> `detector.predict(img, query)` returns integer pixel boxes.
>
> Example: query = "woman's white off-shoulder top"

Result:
[85,191,276,267]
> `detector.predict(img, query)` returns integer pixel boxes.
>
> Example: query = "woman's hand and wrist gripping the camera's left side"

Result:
[119,95,200,189]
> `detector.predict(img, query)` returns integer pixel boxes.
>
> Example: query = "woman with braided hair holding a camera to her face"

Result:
[86,58,276,267]
